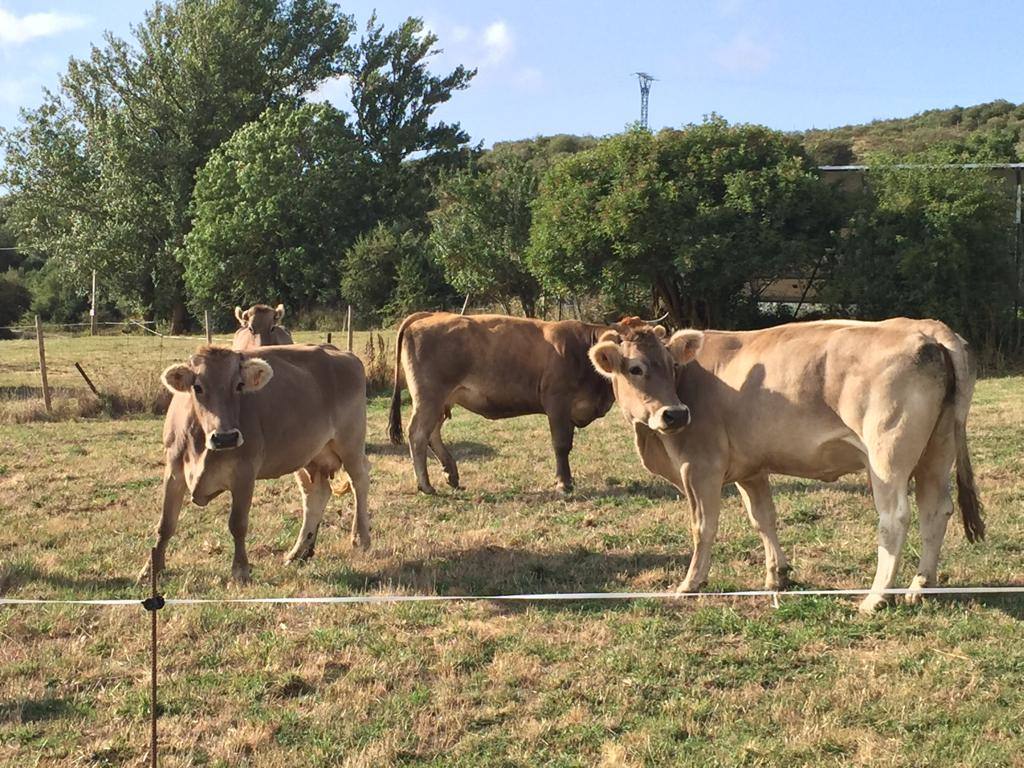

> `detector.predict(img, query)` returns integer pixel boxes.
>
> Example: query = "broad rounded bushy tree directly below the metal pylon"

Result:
[527,117,837,327]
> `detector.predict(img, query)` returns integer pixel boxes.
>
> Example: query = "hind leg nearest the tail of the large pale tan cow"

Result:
[906,413,956,603]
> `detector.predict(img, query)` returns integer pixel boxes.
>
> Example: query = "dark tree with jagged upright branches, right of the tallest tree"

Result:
[347,14,476,221]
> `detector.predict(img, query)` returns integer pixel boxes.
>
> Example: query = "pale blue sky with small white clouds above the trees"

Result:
[0,0,1024,145]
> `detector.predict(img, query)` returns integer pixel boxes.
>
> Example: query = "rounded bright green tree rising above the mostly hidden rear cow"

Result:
[181,104,370,312]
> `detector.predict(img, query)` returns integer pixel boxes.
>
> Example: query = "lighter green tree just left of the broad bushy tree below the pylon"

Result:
[430,151,540,316]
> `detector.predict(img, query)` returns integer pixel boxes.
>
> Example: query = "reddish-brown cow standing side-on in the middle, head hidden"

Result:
[388,312,613,494]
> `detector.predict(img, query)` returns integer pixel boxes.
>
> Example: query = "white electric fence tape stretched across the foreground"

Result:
[0,585,1024,607]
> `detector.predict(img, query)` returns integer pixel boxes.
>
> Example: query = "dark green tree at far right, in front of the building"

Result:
[821,147,1017,357]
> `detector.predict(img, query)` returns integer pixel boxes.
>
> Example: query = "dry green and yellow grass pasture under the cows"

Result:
[0,338,1024,768]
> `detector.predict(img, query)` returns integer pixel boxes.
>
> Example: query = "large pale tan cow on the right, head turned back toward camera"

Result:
[590,318,985,611]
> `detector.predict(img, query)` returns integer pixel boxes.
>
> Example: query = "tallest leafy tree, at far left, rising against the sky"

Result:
[2,0,352,329]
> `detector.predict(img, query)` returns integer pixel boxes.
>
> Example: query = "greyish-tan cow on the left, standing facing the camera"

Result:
[139,344,370,582]
